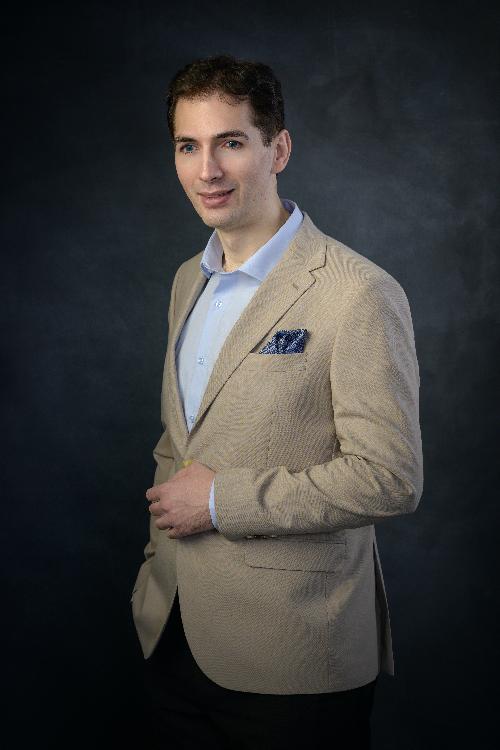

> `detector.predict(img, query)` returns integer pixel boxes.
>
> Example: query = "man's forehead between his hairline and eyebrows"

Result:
[174,94,257,137]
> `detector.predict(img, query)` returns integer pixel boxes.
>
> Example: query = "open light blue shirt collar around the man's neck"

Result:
[200,198,304,281]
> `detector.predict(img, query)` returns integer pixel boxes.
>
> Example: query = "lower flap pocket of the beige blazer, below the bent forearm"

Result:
[244,539,346,572]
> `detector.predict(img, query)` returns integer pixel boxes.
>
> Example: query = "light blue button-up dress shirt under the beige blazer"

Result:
[175,198,304,529]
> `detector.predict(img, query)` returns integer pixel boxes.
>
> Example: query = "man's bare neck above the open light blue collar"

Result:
[217,195,290,271]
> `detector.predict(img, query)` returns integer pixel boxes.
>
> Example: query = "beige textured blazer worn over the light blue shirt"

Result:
[132,214,423,694]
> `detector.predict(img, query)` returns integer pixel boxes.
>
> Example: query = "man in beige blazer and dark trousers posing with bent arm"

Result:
[132,56,422,749]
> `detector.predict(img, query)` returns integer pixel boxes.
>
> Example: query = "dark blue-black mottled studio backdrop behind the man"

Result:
[1,0,500,750]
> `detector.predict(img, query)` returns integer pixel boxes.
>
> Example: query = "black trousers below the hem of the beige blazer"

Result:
[143,594,376,750]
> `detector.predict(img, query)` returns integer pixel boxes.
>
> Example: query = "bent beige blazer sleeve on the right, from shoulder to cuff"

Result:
[215,274,423,540]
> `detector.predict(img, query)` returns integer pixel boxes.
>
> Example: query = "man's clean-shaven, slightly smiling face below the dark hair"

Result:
[174,94,283,231]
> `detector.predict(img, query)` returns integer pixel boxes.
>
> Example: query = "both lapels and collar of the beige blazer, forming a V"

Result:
[165,211,327,445]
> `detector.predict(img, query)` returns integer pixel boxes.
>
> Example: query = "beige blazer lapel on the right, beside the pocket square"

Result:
[189,213,326,438]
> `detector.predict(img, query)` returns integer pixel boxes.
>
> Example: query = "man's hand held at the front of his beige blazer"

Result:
[146,461,215,539]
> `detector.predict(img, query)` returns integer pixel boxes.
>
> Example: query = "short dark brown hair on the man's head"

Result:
[166,55,285,146]
